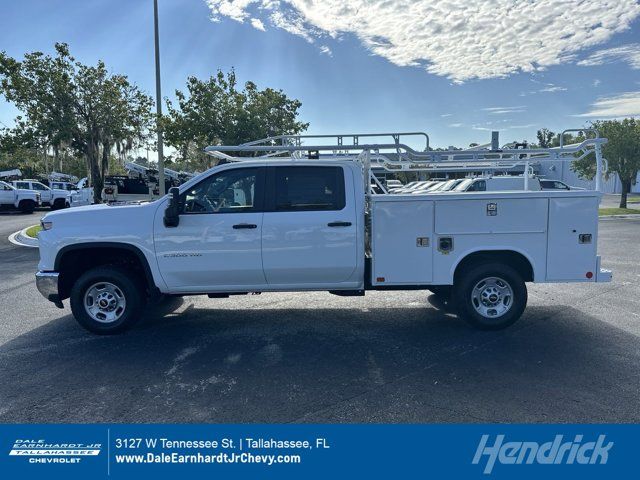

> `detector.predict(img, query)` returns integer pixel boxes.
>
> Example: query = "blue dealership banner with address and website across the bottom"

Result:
[0,424,640,480]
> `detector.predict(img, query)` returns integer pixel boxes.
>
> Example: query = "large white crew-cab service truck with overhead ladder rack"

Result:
[36,134,611,334]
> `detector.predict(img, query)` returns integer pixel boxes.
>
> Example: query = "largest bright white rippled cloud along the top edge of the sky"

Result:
[205,0,640,82]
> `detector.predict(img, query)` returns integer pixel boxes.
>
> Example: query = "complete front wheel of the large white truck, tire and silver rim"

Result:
[70,266,144,335]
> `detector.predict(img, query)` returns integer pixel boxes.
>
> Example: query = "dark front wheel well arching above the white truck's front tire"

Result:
[55,246,155,300]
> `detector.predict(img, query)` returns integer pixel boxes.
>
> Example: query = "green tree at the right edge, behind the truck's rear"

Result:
[571,118,640,208]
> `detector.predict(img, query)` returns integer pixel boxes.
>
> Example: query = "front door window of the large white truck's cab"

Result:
[180,168,258,214]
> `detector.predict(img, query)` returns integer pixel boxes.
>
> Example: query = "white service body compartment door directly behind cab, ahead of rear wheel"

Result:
[371,200,433,285]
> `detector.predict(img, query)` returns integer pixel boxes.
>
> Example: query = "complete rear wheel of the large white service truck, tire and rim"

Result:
[453,262,527,330]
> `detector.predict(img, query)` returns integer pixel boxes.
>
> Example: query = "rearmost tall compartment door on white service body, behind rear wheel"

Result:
[547,197,600,282]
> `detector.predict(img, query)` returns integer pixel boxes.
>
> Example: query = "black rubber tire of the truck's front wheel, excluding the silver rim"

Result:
[70,266,146,335]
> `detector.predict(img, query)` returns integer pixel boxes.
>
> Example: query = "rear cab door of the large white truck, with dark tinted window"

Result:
[262,164,358,287]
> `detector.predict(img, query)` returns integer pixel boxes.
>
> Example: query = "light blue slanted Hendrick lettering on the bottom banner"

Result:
[472,435,613,474]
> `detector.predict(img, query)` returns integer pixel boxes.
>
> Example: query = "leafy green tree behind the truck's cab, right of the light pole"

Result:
[163,70,309,169]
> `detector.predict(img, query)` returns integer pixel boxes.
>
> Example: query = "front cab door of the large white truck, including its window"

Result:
[155,166,265,292]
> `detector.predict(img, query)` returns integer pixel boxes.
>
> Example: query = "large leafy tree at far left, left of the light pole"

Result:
[0,43,153,198]
